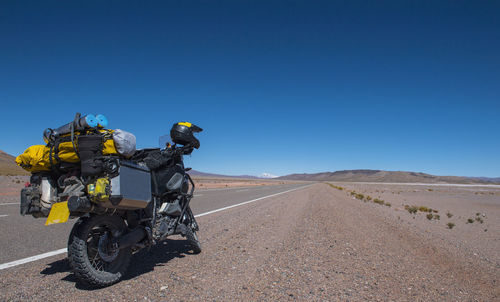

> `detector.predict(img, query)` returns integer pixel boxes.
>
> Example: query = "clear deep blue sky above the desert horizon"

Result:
[0,0,500,177]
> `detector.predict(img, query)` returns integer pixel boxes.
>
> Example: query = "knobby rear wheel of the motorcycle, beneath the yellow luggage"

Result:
[68,215,132,287]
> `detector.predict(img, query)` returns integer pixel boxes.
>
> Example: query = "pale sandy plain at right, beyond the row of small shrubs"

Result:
[336,183,500,268]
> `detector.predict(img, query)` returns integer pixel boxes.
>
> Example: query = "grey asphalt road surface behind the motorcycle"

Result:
[0,184,304,264]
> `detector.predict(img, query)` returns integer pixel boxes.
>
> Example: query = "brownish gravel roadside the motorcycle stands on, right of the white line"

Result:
[0,184,500,301]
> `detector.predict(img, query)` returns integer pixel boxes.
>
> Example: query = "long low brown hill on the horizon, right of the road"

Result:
[278,170,500,184]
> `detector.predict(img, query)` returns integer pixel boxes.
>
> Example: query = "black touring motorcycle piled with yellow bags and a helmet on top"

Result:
[16,114,202,287]
